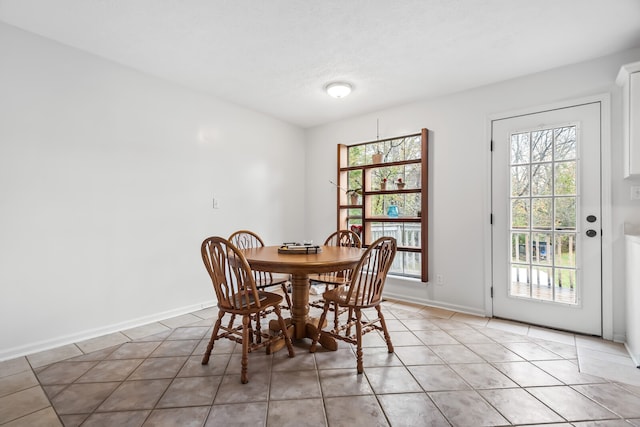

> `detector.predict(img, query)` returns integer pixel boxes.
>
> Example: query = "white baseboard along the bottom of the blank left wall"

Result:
[0,300,216,362]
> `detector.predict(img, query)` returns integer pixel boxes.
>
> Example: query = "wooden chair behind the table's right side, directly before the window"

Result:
[309,230,362,327]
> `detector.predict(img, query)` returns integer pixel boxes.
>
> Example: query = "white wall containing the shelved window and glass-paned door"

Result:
[306,46,640,339]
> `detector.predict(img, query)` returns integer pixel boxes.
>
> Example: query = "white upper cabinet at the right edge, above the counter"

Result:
[616,62,640,178]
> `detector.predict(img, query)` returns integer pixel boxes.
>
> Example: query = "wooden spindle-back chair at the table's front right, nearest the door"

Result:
[309,237,398,374]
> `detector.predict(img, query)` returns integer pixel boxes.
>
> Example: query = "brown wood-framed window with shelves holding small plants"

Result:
[337,129,428,281]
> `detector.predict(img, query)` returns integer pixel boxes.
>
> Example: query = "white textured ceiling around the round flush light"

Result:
[0,0,640,128]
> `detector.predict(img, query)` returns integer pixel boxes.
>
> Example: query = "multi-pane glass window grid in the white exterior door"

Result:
[509,125,578,305]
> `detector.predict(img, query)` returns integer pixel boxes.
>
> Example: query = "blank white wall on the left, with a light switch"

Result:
[0,24,304,360]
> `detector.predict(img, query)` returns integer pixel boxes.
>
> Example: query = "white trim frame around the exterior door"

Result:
[484,92,614,340]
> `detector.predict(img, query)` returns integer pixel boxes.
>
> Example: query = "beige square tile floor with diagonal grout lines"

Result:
[0,301,640,427]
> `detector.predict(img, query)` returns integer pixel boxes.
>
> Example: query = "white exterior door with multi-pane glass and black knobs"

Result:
[491,102,602,336]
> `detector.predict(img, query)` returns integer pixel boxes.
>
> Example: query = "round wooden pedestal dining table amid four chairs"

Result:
[242,246,364,350]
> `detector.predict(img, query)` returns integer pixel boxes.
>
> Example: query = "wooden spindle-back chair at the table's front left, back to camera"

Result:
[200,237,295,384]
